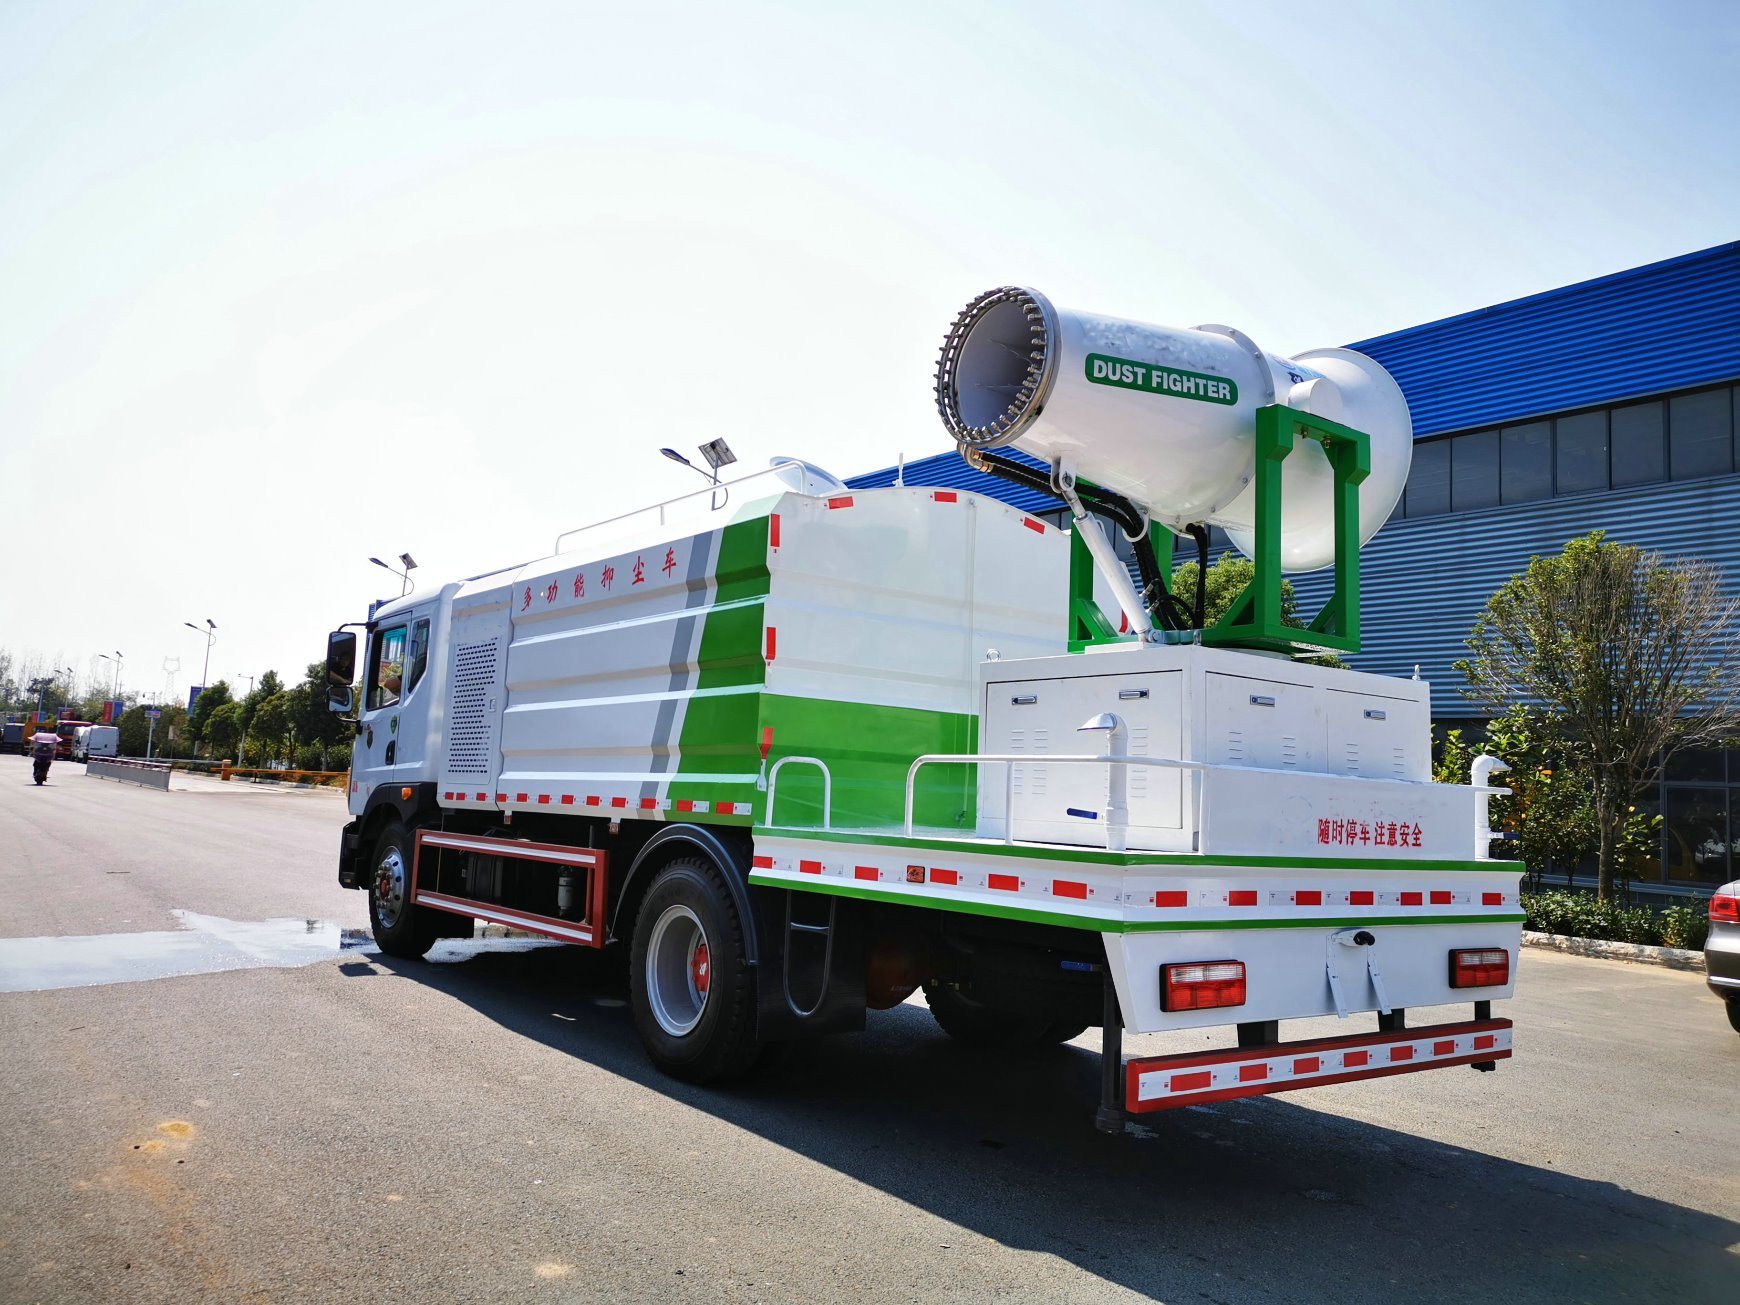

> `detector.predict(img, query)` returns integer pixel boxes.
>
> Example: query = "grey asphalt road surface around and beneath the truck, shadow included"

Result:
[0,759,1740,1305]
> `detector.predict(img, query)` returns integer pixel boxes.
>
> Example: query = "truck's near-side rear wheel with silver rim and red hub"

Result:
[628,856,759,1082]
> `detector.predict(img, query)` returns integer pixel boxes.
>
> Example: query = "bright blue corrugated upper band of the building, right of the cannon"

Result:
[1349,242,1740,438]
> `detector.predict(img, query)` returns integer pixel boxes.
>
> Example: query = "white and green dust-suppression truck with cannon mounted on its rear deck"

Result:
[327,287,1523,1129]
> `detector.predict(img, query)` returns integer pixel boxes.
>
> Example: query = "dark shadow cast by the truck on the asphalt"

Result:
[363,948,1740,1302]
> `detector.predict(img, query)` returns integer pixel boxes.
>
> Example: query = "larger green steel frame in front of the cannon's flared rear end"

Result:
[1204,404,1371,653]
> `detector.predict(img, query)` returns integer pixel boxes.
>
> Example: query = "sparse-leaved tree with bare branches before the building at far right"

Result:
[1456,531,1740,898]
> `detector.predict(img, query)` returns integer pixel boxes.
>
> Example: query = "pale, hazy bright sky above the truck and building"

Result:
[0,0,1740,699]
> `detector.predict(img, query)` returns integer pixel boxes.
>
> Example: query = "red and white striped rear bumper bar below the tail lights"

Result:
[1124,1020,1510,1114]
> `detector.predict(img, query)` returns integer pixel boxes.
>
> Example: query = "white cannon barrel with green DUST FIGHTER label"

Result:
[936,285,1413,571]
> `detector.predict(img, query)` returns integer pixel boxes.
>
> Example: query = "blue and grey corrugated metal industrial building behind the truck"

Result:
[849,242,1740,894]
